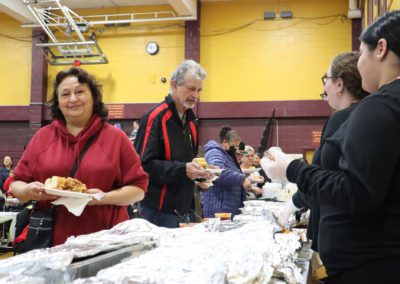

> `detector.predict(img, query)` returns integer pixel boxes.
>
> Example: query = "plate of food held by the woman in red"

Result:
[44,176,93,198]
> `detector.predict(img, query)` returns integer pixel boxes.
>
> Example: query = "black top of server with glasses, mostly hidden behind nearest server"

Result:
[293,104,357,251]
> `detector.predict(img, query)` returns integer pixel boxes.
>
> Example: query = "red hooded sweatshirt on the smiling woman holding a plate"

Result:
[14,115,148,245]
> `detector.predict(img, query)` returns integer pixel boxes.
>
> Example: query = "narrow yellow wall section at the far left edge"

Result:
[0,13,32,105]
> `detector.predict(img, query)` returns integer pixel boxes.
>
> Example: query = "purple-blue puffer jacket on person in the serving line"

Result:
[201,141,246,217]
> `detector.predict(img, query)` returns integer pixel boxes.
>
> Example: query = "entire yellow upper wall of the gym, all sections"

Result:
[0,0,351,105]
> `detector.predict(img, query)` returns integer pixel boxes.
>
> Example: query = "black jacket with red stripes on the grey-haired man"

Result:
[135,95,198,214]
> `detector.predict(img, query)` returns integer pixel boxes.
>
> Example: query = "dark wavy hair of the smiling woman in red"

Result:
[49,67,108,122]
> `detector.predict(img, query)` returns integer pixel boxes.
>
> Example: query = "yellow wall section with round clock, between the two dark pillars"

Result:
[48,6,184,103]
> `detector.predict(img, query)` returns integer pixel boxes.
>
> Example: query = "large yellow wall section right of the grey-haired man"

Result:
[201,0,351,101]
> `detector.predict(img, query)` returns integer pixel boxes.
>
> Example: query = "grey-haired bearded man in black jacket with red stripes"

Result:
[135,60,209,228]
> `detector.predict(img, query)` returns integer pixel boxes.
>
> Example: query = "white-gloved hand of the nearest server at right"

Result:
[260,147,293,185]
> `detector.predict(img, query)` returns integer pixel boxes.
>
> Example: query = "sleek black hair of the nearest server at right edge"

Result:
[360,10,400,59]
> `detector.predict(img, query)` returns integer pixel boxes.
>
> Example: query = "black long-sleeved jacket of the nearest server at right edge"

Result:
[287,80,400,278]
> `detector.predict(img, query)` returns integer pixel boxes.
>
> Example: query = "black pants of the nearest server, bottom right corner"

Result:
[326,257,400,284]
